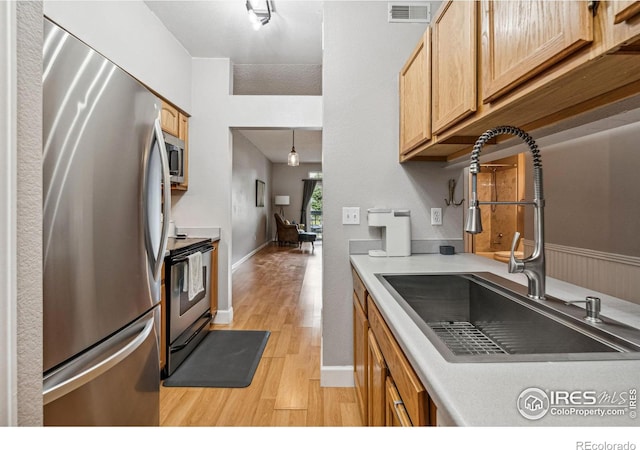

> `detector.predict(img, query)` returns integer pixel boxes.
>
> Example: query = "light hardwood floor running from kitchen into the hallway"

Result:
[160,243,362,427]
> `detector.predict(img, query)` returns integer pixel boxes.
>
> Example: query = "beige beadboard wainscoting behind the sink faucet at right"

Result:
[524,240,640,304]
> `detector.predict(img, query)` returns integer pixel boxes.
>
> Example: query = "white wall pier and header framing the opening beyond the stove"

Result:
[171,58,322,322]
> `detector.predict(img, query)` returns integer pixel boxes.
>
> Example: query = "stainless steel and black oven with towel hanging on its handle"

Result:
[162,238,218,378]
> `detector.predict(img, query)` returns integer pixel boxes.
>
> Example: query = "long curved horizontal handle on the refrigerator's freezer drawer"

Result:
[43,316,155,405]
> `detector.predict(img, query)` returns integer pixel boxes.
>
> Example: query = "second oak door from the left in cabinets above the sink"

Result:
[431,1,478,134]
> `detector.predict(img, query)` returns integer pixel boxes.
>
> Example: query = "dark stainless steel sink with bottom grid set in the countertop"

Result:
[377,272,640,362]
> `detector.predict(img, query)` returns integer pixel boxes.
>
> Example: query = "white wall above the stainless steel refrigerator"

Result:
[44,0,191,113]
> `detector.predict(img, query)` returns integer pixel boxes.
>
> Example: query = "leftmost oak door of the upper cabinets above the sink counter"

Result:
[400,29,431,155]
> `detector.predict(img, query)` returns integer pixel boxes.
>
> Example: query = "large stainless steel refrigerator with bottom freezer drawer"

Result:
[42,19,170,426]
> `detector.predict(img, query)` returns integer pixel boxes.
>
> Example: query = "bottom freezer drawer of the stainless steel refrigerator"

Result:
[44,307,160,426]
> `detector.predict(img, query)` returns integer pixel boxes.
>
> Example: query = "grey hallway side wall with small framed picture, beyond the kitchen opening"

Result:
[231,131,273,265]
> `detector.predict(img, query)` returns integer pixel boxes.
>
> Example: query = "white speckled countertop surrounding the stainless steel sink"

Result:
[351,253,640,426]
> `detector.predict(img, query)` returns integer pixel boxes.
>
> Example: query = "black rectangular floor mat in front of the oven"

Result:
[164,330,271,388]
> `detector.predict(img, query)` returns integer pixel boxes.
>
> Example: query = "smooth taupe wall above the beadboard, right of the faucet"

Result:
[525,123,640,257]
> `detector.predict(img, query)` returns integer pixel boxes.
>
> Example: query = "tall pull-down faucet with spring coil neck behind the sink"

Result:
[465,125,546,300]
